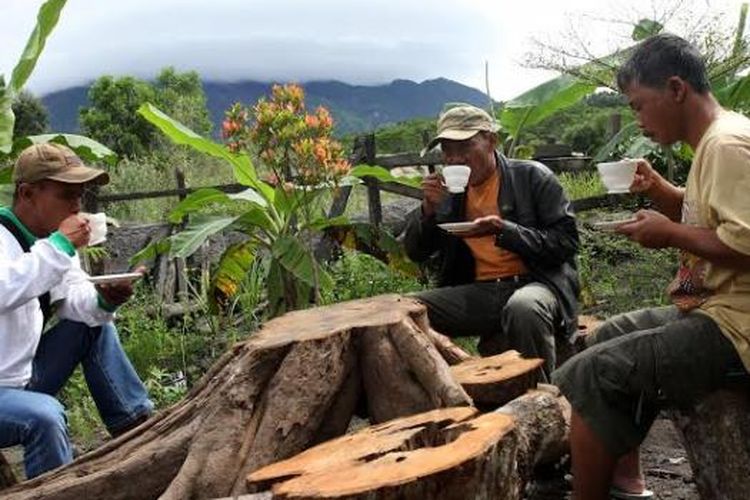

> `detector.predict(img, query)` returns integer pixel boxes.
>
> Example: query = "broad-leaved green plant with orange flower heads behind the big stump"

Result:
[133,85,418,315]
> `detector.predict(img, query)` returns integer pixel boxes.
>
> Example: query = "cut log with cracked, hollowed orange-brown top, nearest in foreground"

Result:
[248,408,518,500]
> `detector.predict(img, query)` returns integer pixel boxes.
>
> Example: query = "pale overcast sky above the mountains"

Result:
[0,0,741,100]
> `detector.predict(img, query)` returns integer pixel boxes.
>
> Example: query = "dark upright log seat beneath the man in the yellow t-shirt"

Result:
[668,383,750,500]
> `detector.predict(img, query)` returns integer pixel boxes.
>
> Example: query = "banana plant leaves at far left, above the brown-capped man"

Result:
[0,0,117,184]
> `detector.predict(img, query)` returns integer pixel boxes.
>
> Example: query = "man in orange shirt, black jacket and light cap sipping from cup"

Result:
[404,104,579,376]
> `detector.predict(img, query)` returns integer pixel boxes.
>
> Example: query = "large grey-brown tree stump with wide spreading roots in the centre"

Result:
[3,295,476,500]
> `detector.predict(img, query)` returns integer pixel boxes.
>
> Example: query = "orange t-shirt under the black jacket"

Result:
[464,173,528,281]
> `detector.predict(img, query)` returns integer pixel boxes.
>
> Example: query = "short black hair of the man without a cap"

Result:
[617,33,710,94]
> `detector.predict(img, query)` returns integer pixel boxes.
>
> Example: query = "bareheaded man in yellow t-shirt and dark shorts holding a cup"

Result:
[554,34,750,500]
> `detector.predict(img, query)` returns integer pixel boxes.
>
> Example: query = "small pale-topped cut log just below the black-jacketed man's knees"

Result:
[450,351,544,410]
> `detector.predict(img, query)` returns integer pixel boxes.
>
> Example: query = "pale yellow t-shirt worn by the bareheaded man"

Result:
[670,112,750,370]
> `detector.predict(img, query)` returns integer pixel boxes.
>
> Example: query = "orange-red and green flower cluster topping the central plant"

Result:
[222,84,350,185]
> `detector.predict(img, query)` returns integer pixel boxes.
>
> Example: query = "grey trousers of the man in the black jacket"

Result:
[415,281,560,380]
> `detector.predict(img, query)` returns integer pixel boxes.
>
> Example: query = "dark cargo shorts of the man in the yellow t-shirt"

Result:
[552,307,746,457]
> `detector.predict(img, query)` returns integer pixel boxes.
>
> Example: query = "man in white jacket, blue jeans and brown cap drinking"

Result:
[0,144,153,478]
